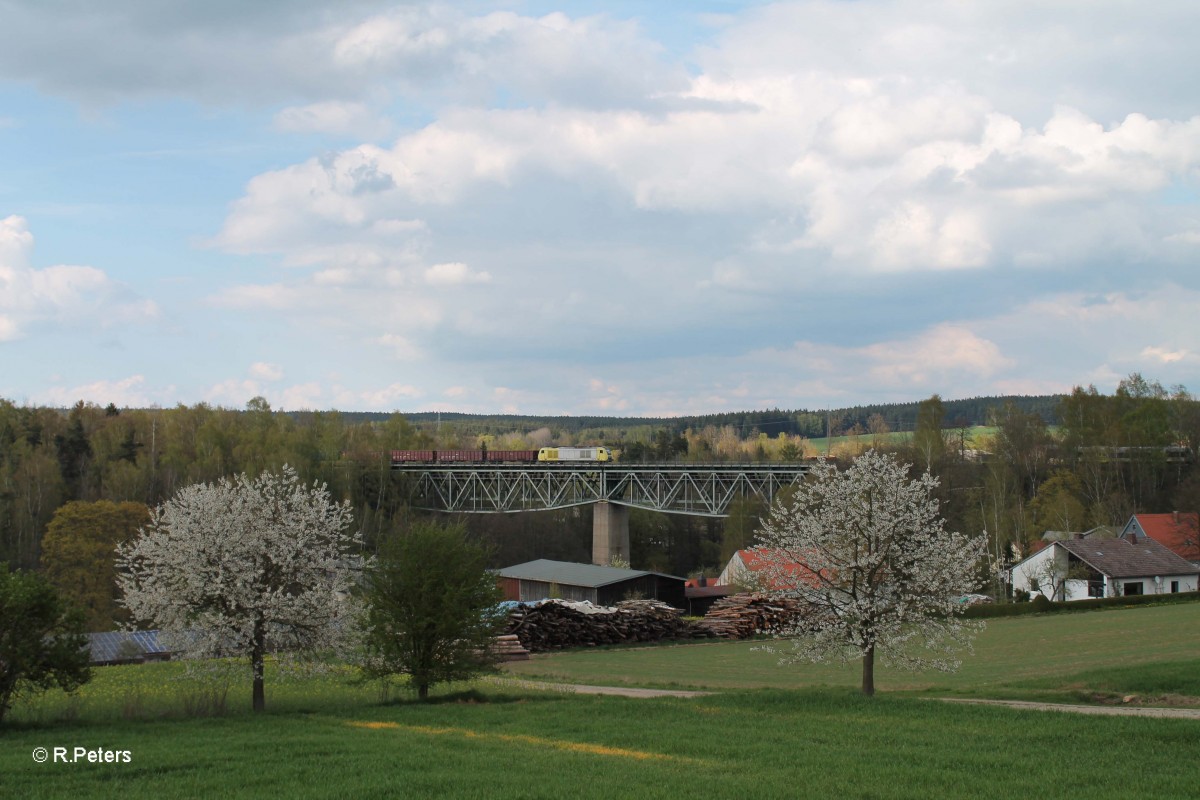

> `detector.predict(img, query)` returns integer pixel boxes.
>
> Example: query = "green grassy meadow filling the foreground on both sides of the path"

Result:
[0,603,1200,799]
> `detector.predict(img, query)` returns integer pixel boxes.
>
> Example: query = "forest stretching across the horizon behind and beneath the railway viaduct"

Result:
[0,374,1200,626]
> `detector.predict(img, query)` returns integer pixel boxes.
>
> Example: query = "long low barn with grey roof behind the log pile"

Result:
[499,559,686,608]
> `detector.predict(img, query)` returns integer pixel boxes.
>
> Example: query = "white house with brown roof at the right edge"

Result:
[1012,535,1200,601]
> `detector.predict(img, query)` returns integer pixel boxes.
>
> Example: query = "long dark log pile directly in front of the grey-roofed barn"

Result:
[505,600,709,652]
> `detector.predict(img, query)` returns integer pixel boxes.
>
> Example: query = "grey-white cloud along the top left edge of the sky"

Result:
[0,0,683,108]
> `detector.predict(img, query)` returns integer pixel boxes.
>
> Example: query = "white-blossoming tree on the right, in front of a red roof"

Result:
[755,451,984,694]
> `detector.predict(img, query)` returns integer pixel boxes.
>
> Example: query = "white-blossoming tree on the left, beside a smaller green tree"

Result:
[118,467,362,711]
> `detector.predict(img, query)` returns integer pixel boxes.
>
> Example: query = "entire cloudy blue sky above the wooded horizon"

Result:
[0,0,1200,416]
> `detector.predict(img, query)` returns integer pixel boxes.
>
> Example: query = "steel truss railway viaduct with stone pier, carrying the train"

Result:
[392,462,810,565]
